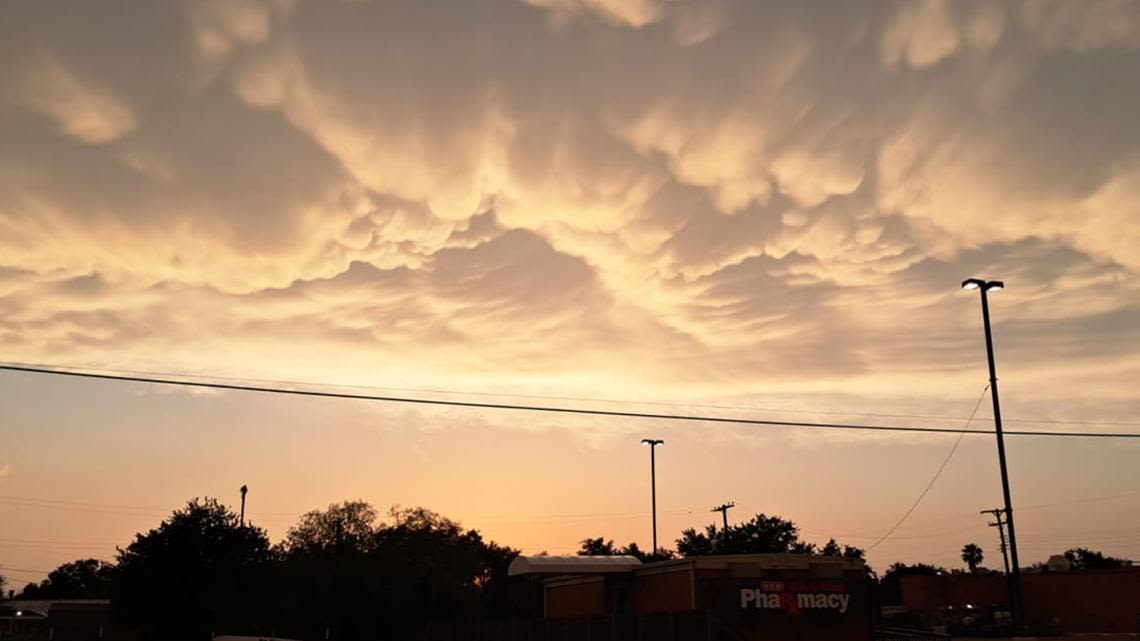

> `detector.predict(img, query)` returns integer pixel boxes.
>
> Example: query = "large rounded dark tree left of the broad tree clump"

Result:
[113,498,275,640]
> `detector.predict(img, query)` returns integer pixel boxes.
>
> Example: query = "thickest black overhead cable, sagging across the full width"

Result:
[0,365,1140,439]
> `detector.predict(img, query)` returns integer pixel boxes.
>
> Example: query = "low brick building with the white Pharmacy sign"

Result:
[490,554,871,641]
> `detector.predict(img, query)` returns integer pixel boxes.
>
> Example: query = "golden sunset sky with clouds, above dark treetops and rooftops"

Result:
[0,0,1140,589]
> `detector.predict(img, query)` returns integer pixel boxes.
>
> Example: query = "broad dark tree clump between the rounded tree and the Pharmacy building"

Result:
[279,501,524,639]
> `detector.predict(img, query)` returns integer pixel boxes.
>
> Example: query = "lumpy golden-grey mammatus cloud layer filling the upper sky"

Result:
[0,0,1140,415]
